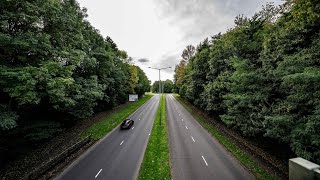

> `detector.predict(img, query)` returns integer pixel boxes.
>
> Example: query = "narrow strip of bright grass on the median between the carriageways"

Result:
[138,95,171,180]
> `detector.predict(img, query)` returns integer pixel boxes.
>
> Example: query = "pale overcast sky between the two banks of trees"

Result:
[78,0,281,82]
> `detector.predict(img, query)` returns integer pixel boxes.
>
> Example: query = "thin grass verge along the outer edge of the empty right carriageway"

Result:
[173,94,276,180]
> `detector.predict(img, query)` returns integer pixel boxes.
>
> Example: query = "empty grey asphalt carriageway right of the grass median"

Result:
[166,94,254,180]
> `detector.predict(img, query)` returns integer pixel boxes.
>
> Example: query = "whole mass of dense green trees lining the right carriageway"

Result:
[175,0,320,163]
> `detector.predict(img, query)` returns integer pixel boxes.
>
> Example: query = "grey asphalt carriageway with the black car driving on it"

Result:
[56,95,159,180]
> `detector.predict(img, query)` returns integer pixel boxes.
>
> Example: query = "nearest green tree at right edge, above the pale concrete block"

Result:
[264,0,320,163]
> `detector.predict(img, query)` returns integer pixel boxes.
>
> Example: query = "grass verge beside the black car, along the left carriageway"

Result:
[80,95,153,140]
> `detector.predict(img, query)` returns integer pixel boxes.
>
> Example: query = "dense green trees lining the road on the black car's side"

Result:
[0,0,150,142]
